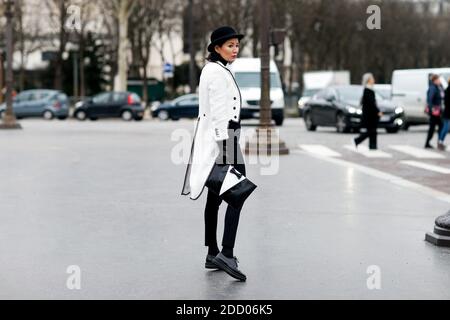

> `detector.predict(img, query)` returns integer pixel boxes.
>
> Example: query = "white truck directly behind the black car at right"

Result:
[298,70,350,116]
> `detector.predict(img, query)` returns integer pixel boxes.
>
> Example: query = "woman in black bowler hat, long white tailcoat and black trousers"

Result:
[182,27,246,281]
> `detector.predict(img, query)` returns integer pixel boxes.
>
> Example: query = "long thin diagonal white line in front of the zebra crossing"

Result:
[292,150,450,203]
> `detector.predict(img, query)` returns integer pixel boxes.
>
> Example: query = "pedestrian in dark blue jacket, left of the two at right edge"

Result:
[425,74,445,149]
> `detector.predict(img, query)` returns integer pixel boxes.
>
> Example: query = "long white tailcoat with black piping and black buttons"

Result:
[182,61,242,200]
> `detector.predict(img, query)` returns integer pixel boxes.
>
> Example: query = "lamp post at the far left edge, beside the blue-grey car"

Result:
[0,0,22,129]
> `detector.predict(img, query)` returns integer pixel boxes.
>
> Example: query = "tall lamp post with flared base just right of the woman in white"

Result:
[245,0,289,156]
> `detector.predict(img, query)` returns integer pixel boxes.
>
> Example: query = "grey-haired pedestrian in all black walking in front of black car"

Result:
[353,73,382,150]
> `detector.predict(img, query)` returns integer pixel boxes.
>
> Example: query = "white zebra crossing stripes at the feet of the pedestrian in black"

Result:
[299,144,450,175]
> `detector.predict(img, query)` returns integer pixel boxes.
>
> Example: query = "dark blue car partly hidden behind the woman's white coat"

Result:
[150,94,199,121]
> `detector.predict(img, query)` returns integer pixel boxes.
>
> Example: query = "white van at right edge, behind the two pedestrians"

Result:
[392,68,450,128]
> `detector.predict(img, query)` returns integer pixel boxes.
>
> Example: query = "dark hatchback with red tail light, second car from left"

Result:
[73,92,145,121]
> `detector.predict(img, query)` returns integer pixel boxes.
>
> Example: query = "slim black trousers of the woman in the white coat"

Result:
[205,121,246,248]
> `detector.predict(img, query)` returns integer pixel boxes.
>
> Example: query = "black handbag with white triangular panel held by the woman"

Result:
[205,163,257,210]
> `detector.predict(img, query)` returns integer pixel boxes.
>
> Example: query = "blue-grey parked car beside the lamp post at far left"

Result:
[0,89,69,120]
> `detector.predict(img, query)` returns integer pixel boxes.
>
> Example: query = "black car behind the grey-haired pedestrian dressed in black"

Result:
[303,85,405,133]
